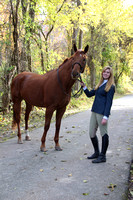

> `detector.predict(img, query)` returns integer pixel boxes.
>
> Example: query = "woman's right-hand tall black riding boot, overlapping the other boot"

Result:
[92,134,109,163]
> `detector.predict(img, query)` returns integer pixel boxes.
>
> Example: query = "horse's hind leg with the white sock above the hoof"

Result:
[25,102,32,141]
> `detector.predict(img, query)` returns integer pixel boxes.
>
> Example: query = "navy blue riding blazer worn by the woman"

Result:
[84,83,115,117]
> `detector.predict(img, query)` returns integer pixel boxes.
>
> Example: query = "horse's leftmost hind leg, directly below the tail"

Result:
[13,99,23,144]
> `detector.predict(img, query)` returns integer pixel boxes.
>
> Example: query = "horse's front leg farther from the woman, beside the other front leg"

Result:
[40,108,54,152]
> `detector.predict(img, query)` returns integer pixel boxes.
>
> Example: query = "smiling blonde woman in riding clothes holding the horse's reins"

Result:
[81,66,115,163]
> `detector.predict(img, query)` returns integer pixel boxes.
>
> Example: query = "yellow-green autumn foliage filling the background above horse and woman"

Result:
[0,0,133,112]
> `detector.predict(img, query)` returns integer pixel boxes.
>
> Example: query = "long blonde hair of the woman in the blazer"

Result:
[95,66,114,92]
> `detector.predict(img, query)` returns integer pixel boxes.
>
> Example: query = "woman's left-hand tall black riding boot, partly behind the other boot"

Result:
[87,136,99,159]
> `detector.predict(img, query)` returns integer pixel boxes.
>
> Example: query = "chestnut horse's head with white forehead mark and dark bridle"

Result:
[71,44,89,79]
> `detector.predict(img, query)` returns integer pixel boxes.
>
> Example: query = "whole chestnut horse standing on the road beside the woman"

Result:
[11,45,88,152]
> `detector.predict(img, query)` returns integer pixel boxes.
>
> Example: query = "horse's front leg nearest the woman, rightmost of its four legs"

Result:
[54,106,66,151]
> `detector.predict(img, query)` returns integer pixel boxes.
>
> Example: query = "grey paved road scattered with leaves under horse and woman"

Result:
[0,95,133,200]
